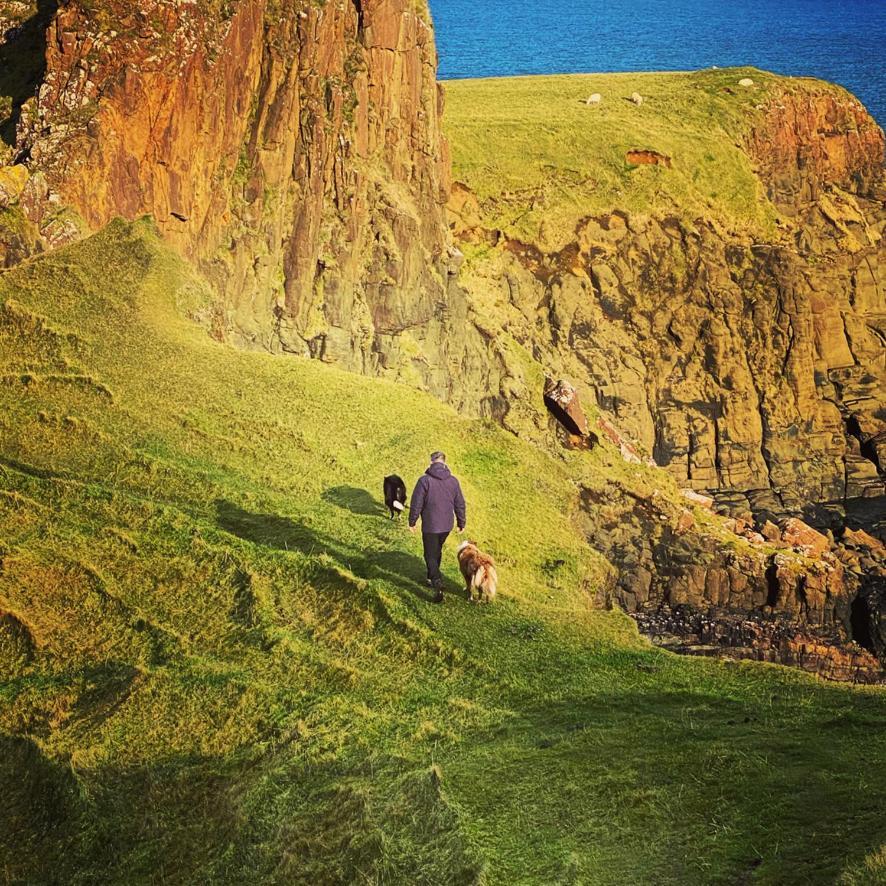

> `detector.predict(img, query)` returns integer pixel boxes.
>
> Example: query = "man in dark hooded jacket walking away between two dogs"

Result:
[409,452,467,603]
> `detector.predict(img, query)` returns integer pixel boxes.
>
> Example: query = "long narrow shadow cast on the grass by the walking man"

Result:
[215,502,452,602]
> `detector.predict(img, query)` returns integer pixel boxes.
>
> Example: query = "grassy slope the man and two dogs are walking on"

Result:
[0,224,886,884]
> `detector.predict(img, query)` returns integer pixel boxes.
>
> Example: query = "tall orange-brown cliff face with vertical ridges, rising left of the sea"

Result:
[0,0,500,396]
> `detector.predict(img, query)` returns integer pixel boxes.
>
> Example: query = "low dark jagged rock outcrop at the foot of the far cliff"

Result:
[581,481,886,683]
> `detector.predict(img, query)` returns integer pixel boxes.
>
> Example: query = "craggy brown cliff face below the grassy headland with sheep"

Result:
[450,85,886,510]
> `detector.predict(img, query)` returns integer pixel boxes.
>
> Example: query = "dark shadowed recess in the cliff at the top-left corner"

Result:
[0,0,58,153]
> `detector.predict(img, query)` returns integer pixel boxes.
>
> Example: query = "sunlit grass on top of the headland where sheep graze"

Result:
[444,68,860,251]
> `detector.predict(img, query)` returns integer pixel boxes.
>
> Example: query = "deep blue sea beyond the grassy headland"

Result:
[430,0,886,125]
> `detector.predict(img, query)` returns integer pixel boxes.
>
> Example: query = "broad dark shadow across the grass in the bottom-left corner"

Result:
[0,736,479,884]
